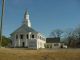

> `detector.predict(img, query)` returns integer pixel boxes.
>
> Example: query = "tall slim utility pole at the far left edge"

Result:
[0,0,5,46]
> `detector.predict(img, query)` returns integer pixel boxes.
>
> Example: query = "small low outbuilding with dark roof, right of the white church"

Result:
[45,37,64,48]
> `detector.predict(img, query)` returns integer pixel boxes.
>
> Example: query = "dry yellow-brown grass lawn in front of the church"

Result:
[0,48,80,60]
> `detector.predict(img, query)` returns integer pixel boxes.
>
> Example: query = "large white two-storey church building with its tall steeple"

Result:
[11,11,46,49]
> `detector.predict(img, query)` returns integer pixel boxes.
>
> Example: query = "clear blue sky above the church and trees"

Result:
[0,0,80,37]
